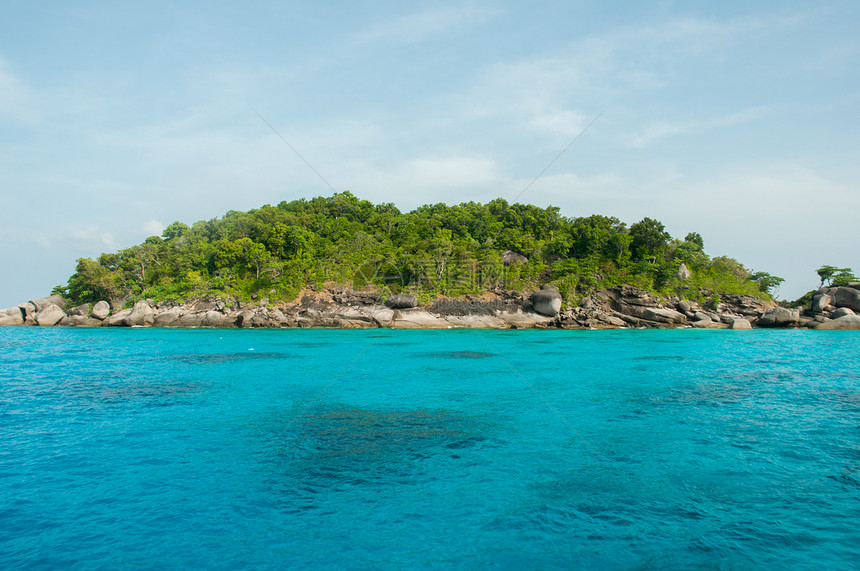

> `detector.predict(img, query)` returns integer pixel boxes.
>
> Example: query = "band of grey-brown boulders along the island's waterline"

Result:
[0,283,860,329]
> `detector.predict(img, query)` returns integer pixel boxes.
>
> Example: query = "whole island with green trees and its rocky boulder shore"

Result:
[0,191,860,329]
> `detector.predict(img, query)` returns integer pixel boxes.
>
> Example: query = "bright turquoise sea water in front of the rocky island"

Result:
[0,327,860,569]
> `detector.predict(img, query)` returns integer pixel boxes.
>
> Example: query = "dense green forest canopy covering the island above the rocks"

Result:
[56,191,782,306]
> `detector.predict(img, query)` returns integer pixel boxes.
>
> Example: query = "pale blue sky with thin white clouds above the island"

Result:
[0,0,860,307]
